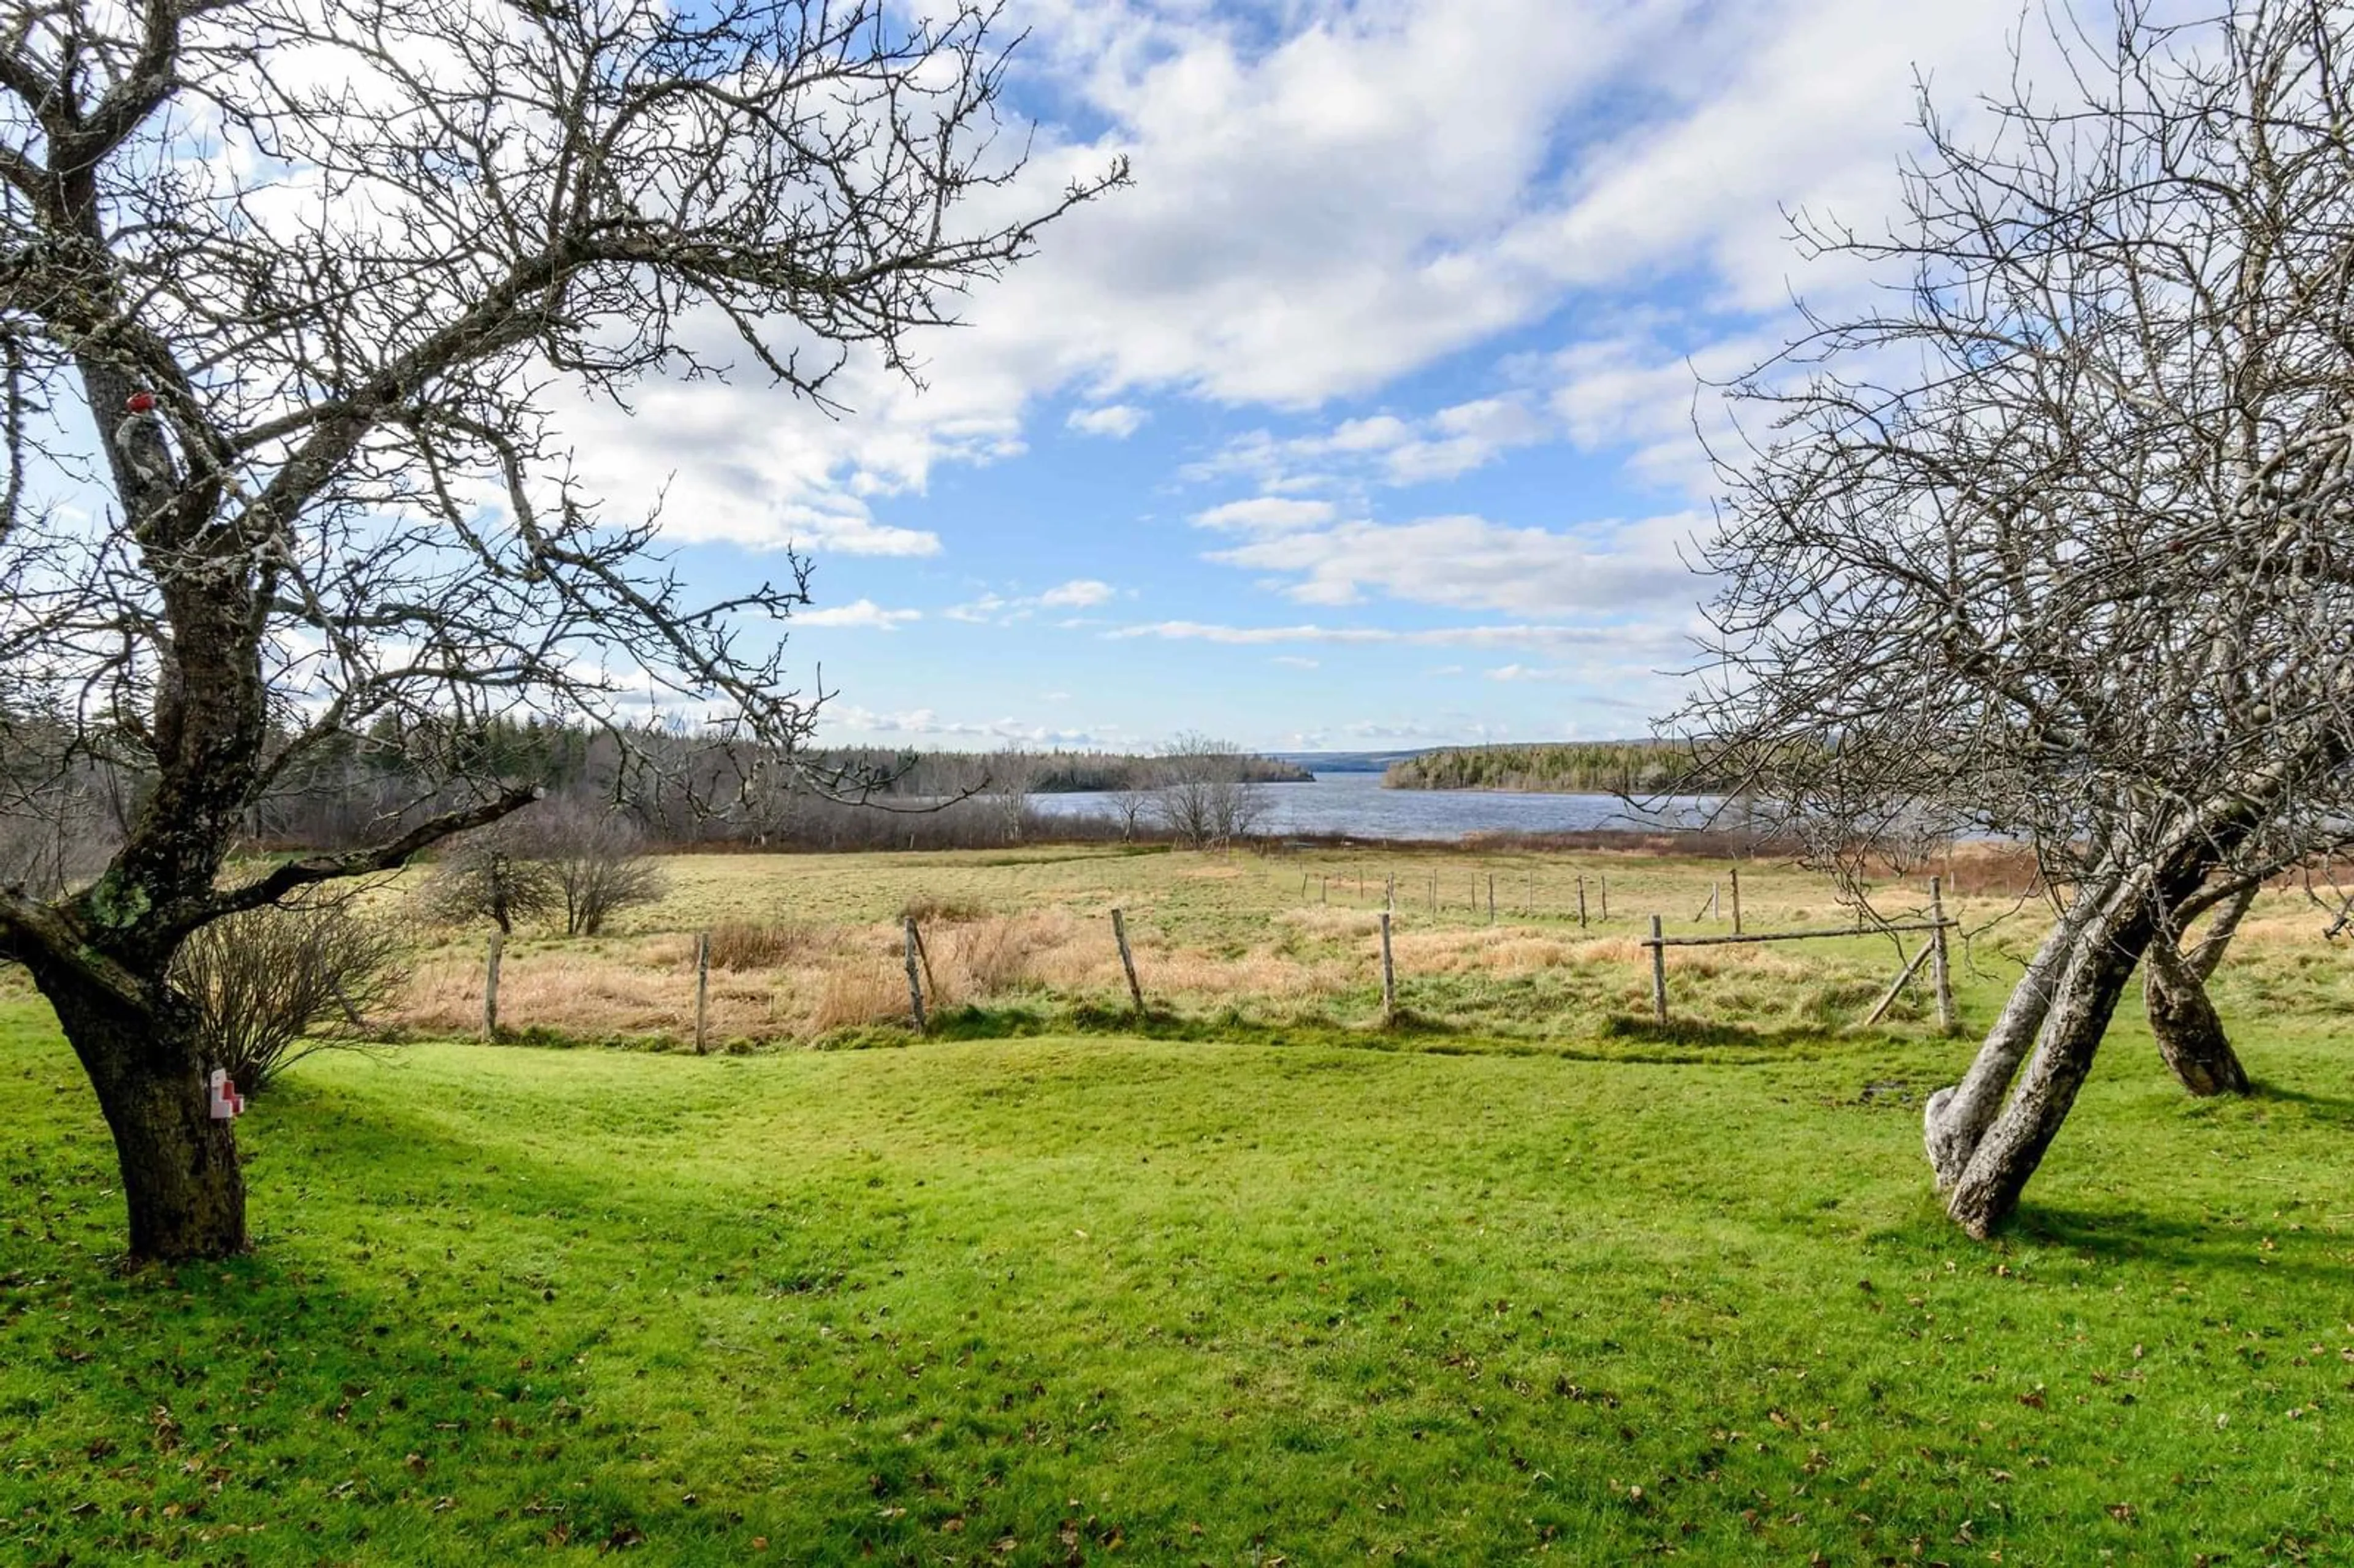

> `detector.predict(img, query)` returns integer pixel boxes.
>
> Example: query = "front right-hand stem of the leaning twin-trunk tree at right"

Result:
[1945,892,2156,1241]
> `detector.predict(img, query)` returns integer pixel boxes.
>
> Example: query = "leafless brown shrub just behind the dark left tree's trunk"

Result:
[172,904,403,1095]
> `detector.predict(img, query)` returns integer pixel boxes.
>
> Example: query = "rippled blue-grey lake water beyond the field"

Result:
[1031,772,1704,838]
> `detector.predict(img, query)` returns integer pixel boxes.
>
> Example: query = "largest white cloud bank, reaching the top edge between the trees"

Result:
[525,0,2036,555]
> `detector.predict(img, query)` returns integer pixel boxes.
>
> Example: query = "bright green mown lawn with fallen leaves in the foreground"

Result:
[0,989,2354,1566]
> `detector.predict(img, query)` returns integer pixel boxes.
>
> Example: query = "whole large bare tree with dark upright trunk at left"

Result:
[0,0,1123,1257]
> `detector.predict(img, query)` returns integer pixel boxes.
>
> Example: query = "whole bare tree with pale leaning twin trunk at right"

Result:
[1685,0,2354,1236]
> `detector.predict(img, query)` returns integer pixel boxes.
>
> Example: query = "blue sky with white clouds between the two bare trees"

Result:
[569,0,2020,748]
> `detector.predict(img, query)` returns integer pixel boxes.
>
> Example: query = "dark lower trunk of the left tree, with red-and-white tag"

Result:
[42,975,247,1262]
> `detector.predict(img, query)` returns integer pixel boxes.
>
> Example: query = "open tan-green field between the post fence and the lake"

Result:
[376,848,2081,1048]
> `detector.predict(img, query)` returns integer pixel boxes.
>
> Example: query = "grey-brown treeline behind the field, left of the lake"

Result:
[0,718,1314,892]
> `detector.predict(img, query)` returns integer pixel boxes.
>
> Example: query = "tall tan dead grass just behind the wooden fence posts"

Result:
[376,857,2128,1043]
